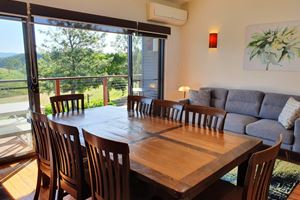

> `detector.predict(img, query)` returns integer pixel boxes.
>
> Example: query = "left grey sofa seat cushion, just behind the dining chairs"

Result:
[224,113,258,134]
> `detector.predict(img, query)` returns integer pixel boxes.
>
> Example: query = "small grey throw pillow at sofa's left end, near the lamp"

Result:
[189,89,211,106]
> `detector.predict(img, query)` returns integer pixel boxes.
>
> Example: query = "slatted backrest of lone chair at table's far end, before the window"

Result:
[50,94,84,114]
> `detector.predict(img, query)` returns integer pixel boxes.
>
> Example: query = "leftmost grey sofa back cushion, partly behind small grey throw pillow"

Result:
[201,87,228,109]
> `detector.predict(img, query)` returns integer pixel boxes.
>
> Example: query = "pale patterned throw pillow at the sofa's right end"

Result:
[278,97,300,129]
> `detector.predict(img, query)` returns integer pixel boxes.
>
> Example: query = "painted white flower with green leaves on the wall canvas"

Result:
[247,27,300,70]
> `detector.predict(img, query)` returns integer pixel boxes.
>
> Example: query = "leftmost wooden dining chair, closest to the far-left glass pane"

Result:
[31,112,57,200]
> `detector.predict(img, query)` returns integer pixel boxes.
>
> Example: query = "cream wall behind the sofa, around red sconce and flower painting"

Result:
[180,0,300,94]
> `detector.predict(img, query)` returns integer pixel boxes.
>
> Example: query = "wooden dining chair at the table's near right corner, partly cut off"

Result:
[196,135,282,200]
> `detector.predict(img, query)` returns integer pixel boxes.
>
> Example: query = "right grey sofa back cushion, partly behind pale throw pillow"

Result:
[259,93,300,120]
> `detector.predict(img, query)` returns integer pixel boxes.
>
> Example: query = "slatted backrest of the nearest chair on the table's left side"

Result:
[83,130,130,200]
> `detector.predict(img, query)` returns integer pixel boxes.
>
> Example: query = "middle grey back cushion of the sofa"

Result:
[225,90,264,117]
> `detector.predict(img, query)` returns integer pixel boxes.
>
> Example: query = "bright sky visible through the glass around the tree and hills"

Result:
[0,19,122,53]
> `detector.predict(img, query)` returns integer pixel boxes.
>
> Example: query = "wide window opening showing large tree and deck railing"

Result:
[35,17,162,114]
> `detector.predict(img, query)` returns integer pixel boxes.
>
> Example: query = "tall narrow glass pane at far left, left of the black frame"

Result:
[0,19,33,160]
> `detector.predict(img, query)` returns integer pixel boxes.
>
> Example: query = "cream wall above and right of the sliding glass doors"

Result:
[20,0,180,99]
